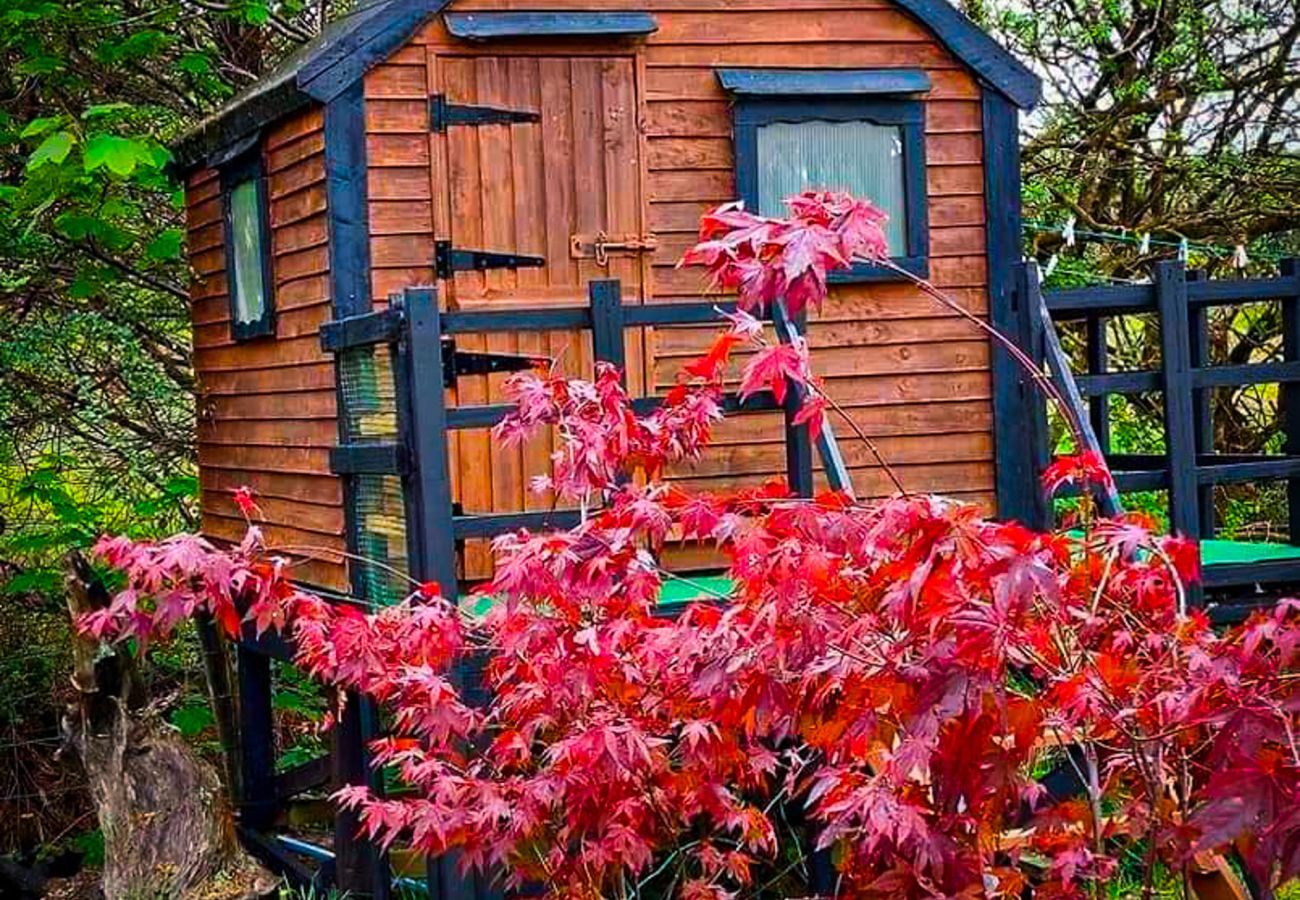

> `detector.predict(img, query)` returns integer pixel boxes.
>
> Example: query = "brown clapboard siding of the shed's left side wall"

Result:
[186,111,347,589]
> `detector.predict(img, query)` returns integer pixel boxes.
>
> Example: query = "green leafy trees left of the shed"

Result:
[0,0,337,587]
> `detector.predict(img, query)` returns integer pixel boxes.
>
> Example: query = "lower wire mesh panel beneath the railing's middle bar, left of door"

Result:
[352,475,411,606]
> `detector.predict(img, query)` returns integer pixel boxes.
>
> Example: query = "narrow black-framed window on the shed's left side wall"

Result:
[221,152,276,341]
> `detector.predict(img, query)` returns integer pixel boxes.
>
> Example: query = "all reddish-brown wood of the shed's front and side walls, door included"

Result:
[190,0,995,585]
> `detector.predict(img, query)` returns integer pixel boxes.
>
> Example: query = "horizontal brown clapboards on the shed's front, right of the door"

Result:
[400,0,993,520]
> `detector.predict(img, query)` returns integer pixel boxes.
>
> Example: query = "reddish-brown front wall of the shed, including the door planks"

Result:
[365,0,995,574]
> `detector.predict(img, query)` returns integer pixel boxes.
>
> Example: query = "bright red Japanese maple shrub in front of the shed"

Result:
[82,194,1300,899]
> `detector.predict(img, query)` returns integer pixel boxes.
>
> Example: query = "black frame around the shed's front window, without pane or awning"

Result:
[733,94,930,284]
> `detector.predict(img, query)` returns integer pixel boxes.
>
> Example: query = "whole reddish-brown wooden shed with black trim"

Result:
[178,0,1039,600]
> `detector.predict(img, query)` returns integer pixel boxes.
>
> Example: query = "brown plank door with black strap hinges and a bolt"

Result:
[430,55,647,577]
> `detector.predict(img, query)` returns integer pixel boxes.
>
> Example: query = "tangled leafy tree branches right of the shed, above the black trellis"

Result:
[967,0,1300,261]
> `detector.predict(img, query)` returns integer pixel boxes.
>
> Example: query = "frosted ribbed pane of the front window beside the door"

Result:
[758,120,907,256]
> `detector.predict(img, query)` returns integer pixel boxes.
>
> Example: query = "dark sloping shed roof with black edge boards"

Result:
[176,0,1041,170]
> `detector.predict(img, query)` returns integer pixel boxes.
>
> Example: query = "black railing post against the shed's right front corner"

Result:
[1015,261,1053,529]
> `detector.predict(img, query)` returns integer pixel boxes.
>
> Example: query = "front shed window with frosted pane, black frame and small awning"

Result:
[723,70,930,281]
